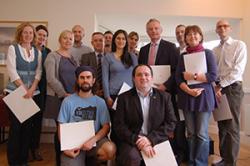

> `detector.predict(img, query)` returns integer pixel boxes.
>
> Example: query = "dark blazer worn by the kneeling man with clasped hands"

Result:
[113,88,176,146]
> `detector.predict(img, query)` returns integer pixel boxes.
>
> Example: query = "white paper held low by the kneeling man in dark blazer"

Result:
[142,141,177,166]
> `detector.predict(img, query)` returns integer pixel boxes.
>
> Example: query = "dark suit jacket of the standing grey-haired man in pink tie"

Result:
[138,39,180,93]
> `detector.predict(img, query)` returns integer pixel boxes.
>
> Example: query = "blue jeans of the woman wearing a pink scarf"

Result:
[184,111,211,166]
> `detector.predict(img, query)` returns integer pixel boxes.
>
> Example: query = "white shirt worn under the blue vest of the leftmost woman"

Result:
[6,44,42,82]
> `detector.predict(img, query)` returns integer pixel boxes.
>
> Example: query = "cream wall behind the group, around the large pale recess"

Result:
[0,0,250,90]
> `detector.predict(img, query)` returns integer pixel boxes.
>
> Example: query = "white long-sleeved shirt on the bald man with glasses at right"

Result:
[213,37,247,87]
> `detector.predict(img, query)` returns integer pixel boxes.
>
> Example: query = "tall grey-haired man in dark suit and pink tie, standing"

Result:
[138,18,180,162]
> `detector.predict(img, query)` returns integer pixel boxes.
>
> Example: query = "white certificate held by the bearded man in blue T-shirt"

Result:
[60,120,95,151]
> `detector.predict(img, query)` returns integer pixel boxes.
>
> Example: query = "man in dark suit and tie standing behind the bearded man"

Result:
[80,32,104,97]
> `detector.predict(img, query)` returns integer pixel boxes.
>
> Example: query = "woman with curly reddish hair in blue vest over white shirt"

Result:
[6,22,42,166]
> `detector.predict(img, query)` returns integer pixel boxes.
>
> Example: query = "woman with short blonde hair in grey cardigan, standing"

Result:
[44,30,78,165]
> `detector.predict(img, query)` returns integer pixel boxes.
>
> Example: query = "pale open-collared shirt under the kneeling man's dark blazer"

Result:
[136,88,153,135]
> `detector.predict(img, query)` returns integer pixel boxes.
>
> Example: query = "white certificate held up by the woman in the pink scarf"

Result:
[184,51,207,85]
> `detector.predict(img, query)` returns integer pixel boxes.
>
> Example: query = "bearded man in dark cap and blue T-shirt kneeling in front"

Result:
[58,66,116,166]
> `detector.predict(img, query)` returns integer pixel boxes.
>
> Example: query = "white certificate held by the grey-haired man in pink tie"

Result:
[151,65,171,85]
